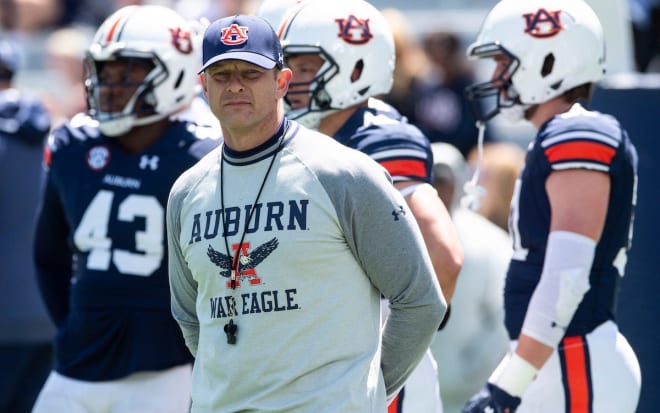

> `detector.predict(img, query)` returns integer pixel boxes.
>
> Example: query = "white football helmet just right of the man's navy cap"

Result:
[279,0,395,128]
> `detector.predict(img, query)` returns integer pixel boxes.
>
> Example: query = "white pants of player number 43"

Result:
[32,364,192,413]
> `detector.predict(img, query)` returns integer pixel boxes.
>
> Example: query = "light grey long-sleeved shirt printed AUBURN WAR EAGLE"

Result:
[167,120,446,413]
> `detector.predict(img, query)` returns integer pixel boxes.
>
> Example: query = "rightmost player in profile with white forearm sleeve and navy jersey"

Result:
[463,0,640,413]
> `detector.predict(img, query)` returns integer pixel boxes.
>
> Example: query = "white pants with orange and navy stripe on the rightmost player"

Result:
[512,321,642,413]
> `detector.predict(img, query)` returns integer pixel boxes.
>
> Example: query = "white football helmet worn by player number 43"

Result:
[85,5,204,136]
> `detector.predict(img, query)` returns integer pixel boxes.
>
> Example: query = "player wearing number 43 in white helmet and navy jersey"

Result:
[34,5,221,413]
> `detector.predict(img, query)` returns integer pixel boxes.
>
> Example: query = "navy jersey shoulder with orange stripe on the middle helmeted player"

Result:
[334,99,433,183]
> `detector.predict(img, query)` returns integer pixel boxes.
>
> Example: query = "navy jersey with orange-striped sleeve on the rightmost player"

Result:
[504,105,637,339]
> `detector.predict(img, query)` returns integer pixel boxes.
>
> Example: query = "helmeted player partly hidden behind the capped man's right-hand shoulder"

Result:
[268,0,463,413]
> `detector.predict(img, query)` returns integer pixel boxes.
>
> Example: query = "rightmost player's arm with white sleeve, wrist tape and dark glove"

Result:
[464,169,610,412]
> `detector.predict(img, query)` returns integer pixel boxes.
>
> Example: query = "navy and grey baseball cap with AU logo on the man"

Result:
[198,15,284,73]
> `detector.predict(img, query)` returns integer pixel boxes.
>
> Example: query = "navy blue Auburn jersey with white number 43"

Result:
[35,116,221,381]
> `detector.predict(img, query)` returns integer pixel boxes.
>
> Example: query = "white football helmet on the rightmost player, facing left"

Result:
[466,0,605,121]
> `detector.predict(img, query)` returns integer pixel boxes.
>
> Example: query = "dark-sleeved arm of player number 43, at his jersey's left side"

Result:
[33,179,73,326]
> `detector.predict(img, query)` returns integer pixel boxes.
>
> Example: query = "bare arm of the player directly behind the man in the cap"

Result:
[395,181,463,303]
